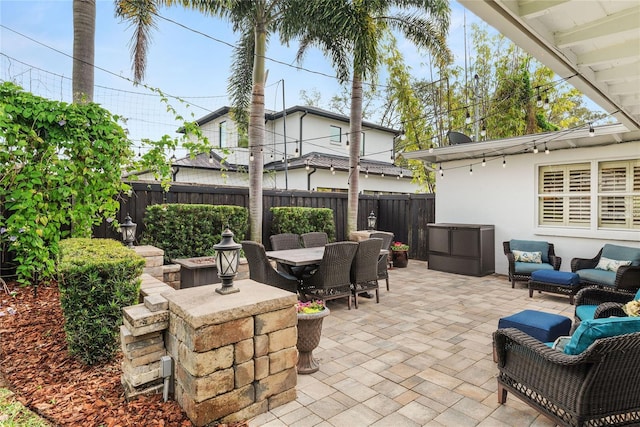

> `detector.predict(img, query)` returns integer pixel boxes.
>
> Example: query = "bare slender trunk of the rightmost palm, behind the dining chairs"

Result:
[346,73,362,236]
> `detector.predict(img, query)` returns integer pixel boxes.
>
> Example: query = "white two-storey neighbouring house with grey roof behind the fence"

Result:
[164,106,420,194]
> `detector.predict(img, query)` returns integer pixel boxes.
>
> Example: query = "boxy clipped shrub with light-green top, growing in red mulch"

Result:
[58,239,145,365]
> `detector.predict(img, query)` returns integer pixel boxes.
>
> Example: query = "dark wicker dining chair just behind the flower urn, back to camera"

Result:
[300,242,358,310]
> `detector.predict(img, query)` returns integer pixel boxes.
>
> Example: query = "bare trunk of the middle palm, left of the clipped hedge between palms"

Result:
[249,22,267,243]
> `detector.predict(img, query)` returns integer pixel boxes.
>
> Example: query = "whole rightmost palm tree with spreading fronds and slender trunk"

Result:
[286,0,450,233]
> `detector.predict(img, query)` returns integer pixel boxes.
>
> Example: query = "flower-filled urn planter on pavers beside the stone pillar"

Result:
[296,300,329,374]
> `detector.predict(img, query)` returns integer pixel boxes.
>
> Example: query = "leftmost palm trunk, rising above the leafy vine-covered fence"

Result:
[72,0,96,103]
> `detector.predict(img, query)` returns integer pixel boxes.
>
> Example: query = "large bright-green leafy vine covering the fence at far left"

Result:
[0,82,132,284]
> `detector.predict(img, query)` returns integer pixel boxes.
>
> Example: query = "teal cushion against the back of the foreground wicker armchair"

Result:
[564,317,640,354]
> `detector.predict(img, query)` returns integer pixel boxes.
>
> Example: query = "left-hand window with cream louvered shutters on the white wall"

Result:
[538,163,591,227]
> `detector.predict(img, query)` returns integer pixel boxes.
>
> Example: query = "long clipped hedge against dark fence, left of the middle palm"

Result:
[142,203,249,261]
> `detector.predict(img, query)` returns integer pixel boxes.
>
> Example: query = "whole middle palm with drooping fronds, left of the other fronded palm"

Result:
[116,0,320,242]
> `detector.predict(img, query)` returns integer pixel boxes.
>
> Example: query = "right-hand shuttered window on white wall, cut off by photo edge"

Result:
[598,160,640,229]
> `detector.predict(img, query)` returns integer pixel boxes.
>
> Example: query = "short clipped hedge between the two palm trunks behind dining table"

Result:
[271,207,336,242]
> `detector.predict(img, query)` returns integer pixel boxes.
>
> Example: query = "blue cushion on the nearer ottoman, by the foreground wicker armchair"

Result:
[498,310,571,342]
